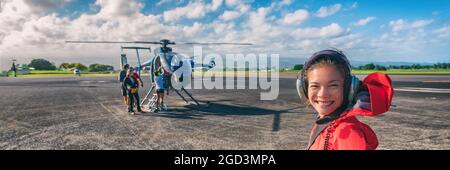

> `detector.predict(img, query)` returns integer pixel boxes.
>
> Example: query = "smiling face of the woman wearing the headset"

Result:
[307,65,344,117]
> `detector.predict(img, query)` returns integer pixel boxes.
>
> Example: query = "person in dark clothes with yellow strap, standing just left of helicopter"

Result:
[122,69,142,115]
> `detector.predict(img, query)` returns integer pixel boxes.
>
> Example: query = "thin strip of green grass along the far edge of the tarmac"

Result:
[3,69,450,77]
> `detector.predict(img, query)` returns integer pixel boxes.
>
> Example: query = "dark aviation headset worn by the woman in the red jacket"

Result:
[297,49,361,124]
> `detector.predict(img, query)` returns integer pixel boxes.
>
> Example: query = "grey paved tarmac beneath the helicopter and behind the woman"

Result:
[0,75,450,149]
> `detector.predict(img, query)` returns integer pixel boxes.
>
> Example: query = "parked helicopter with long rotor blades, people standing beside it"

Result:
[66,39,253,110]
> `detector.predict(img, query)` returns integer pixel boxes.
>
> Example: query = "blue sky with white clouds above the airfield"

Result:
[0,0,450,67]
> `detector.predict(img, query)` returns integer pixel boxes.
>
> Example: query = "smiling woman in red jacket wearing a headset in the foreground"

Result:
[297,50,393,150]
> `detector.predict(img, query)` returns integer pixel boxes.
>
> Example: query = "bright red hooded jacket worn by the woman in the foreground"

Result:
[308,73,394,150]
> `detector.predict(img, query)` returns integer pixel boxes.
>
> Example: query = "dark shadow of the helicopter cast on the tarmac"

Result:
[141,101,301,132]
